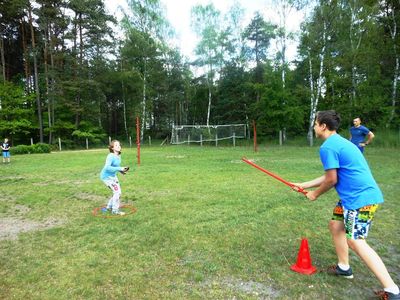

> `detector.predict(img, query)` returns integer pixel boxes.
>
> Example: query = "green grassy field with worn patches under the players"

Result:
[0,146,400,299]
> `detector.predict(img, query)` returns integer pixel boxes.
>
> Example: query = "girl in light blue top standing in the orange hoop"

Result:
[100,140,129,215]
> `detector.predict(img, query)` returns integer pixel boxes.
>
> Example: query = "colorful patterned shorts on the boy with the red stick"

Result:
[332,200,379,240]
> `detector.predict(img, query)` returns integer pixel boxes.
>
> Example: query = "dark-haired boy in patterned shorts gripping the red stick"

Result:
[295,110,400,300]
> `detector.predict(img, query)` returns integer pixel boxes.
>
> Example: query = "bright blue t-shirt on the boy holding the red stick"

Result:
[319,134,383,209]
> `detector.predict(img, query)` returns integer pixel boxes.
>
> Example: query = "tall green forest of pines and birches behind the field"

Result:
[0,0,400,148]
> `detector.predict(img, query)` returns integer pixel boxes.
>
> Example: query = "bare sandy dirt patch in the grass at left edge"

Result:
[0,217,63,240]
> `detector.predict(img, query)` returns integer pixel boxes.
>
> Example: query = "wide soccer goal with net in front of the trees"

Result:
[171,124,247,146]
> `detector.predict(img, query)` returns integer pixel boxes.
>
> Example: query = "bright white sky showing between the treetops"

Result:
[105,0,303,61]
